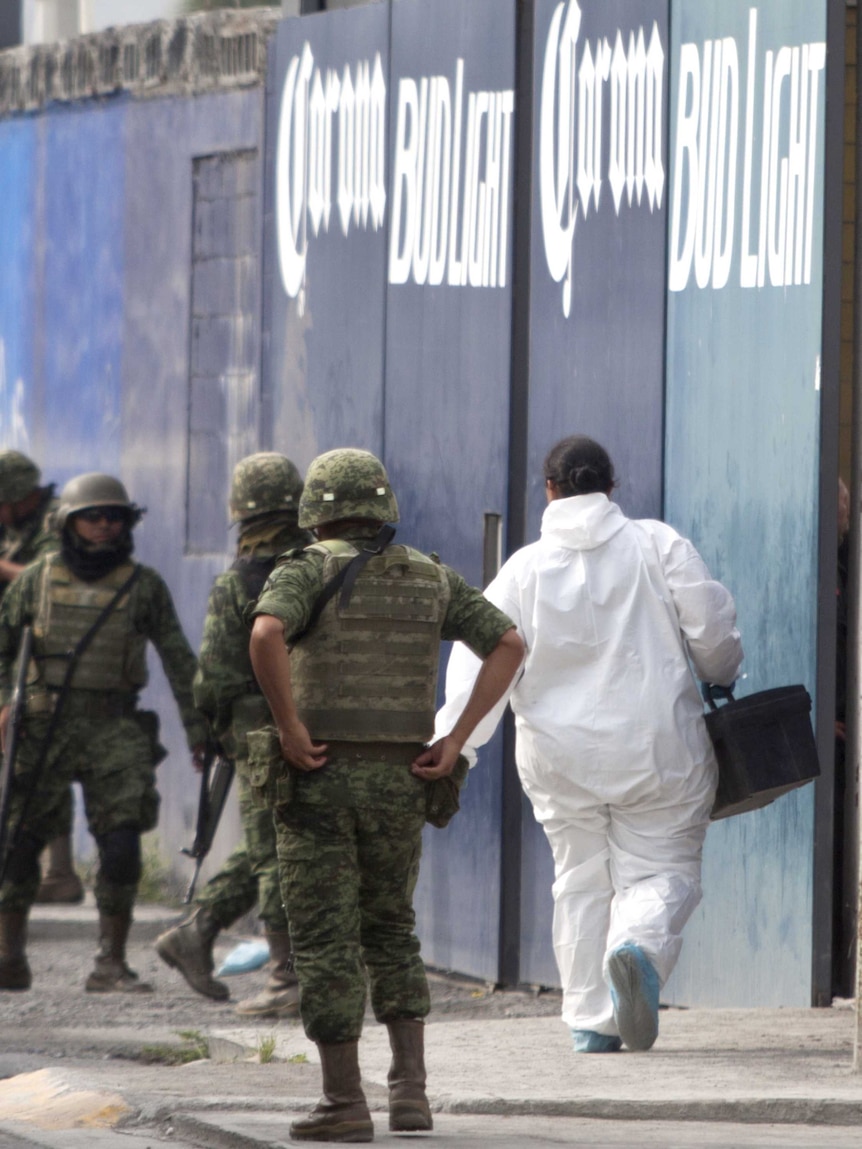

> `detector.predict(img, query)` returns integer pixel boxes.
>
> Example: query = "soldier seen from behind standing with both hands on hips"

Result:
[248,449,523,1141]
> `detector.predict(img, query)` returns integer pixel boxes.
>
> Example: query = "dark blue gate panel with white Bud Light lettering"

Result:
[385,0,516,980]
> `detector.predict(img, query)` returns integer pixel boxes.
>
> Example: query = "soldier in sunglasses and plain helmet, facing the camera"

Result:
[0,475,207,993]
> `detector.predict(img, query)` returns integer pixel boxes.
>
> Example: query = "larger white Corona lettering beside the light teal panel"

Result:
[539,0,664,317]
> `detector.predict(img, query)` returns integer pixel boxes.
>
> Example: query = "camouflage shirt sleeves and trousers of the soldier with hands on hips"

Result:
[249,526,514,1044]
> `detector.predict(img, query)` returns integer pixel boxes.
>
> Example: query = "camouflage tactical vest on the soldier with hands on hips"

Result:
[291,539,449,742]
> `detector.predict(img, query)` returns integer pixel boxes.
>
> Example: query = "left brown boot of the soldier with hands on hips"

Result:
[291,1041,375,1142]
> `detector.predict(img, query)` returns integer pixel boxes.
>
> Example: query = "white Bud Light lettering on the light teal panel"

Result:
[668,8,826,291]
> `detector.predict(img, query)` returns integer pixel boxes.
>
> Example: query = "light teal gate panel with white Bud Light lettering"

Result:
[664,0,826,1007]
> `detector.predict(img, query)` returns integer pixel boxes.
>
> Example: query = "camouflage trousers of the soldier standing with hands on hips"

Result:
[277,742,430,1043]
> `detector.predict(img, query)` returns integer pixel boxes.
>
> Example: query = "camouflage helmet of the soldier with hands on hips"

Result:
[299,447,399,527]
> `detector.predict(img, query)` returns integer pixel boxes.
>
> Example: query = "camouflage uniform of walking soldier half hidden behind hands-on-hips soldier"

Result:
[194,525,308,933]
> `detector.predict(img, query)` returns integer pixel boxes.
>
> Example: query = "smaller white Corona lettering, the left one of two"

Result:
[276,43,386,315]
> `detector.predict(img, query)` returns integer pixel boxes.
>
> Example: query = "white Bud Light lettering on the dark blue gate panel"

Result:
[388,59,515,287]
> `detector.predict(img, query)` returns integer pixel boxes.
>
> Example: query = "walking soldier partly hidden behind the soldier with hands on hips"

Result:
[155,452,311,1017]
